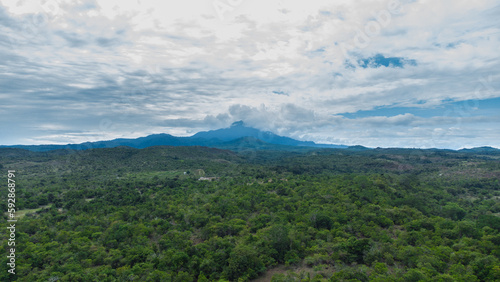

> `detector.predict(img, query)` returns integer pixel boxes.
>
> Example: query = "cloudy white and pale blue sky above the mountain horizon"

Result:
[0,0,500,149]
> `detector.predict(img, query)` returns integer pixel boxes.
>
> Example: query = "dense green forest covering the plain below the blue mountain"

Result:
[0,146,500,282]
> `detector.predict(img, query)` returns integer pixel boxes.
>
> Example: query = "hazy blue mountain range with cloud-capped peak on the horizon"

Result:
[0,121,348,152]
